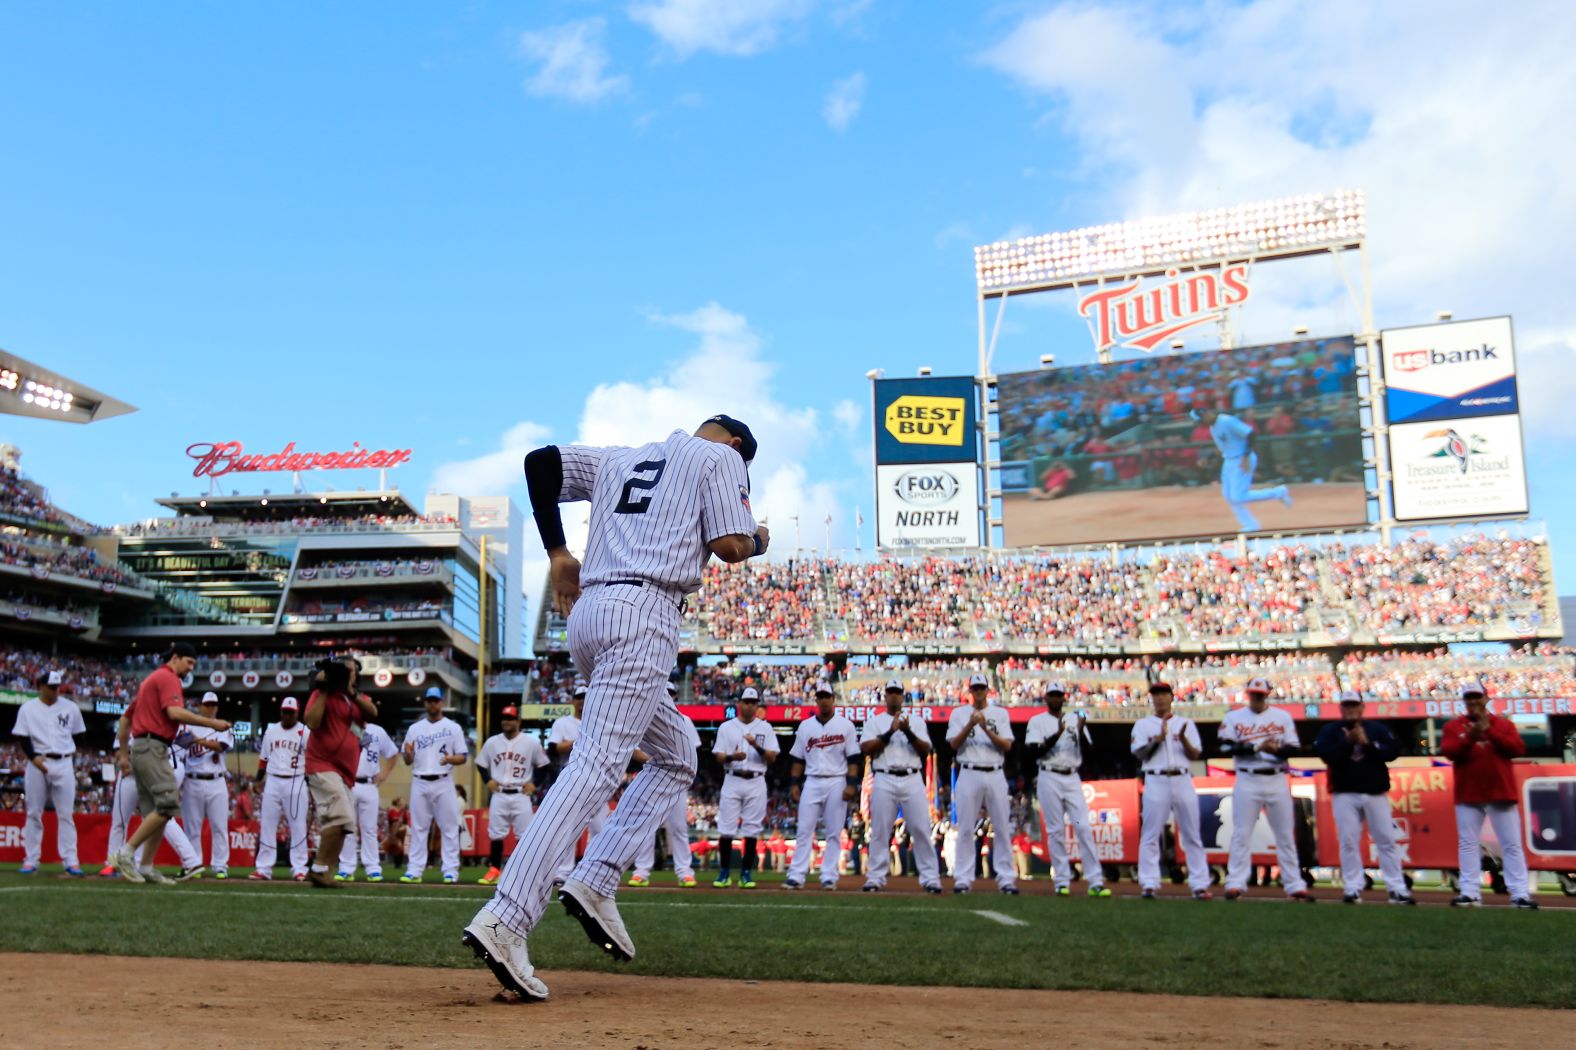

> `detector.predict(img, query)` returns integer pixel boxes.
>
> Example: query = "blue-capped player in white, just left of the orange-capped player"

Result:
[399,686,471,883]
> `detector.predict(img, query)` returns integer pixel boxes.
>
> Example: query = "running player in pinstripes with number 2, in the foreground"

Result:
[463,416,769,1000]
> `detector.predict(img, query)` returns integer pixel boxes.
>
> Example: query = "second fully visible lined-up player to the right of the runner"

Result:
[783,681,864,889]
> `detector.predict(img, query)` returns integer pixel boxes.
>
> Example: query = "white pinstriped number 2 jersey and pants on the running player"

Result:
[487,430,756,933]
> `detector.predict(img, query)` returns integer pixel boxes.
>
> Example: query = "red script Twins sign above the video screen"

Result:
[1078,263,1248,350]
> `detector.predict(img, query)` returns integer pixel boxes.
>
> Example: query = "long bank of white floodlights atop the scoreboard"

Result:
[974,189,1368,298]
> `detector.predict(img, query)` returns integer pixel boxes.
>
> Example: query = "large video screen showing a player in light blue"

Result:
[998,336,1368,547]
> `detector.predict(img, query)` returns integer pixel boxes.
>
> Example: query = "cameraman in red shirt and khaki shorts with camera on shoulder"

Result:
[301,659,378,889]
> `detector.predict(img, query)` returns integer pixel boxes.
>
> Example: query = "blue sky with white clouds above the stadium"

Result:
[0,0,1576,590]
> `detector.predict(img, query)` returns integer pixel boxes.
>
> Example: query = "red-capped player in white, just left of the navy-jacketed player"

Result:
[1220,678,1318,903]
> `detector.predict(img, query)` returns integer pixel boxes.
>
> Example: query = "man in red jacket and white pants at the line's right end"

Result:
[1439,683,1538,910]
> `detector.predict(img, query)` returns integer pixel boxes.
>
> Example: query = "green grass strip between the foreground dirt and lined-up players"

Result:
[0,872,1576,1009]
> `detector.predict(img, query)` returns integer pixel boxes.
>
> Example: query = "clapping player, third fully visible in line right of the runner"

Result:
[859,678,941,894]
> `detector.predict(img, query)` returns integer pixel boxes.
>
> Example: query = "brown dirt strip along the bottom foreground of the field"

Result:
[0,955,1571,1050]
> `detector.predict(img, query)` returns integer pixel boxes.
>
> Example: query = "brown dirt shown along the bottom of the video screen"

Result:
[1002,481,1368,547]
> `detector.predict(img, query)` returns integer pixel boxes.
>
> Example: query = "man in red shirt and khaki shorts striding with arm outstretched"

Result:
[112,642,230,883]
